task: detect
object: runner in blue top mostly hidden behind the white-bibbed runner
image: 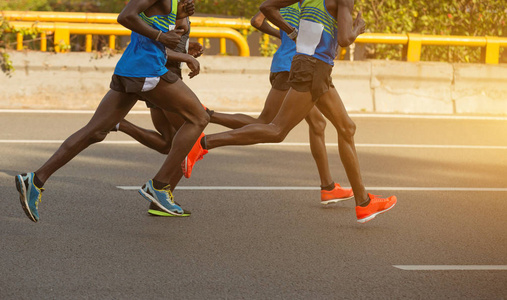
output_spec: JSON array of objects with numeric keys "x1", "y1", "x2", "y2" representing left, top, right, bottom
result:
[{"x1": 206, "y1": 3, "x2": 354, "y2": 204}]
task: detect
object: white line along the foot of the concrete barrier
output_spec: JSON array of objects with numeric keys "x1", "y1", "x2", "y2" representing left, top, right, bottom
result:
[{"x1": 0, "y1": 109, "x2": 507, "y2": 121}]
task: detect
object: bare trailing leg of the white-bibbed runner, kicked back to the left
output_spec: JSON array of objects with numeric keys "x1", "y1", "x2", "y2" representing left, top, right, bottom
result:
[{"x1": 206, "y1": 89, "x2": 314, "y2": 149}]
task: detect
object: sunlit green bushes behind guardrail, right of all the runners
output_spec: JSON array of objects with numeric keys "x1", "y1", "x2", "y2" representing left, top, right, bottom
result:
[{"x1": 356, "y1": 0, "x2": 507, "y2": 62}]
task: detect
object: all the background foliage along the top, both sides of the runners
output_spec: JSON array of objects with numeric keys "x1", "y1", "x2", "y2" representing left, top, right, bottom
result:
[{"x1": 0, "y1": 0, "x2": 507, "y2": 62}]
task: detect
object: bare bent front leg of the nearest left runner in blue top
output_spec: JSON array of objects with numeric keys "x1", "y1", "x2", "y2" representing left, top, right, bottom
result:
[{"x1": 144, "y1": 80, "x2": 209, "y2": 188}]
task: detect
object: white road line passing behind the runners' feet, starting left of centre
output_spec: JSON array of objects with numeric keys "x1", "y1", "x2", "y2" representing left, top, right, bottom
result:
[{"x1": 116, "y1": 185, "x2": 507, "y2": 192}]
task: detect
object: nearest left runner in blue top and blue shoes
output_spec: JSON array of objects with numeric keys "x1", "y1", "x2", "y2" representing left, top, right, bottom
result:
[{"x1": 15, "y1": 0, "x2": 209, "y2": 222}]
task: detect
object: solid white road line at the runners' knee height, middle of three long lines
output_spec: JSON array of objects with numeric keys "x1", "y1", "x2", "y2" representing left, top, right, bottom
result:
[{"x1": 0, "y1": 140, "x2": 507, "y2": 150}]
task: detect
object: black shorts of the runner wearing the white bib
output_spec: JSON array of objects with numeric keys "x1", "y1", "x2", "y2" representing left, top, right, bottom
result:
[{"x1": 289, "y1": 54, "x2": 334, "y2": 101}]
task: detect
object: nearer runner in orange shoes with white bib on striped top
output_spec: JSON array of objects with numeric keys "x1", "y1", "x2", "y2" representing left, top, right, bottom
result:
[{"x1": 189, "y1": 0, "x2": 397, "y2": 223}]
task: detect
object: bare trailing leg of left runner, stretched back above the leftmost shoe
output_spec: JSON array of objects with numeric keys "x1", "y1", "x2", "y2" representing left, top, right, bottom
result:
[{"x1": 35, "y1": 90, "x2": 137, "y2": 183}]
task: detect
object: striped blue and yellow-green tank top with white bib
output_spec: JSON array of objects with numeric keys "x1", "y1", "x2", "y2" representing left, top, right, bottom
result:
[{"x1": 296, "y1": 0, "x2": 338, "y2": 66}]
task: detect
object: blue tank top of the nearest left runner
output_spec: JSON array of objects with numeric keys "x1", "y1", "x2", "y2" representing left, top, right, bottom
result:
[{"x1": 114, "y1": 0, "x2": 178, "y2": 77}]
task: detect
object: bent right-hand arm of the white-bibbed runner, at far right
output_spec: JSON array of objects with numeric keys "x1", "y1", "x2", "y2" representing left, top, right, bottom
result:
[{"x1": 336, "y1": 0, "x2": 366, "y2": 47}]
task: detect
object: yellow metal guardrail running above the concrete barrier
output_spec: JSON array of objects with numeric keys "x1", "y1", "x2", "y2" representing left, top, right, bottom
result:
[{"x1": 0, "y1": 11, "x2": 507, "y2": 64}]
